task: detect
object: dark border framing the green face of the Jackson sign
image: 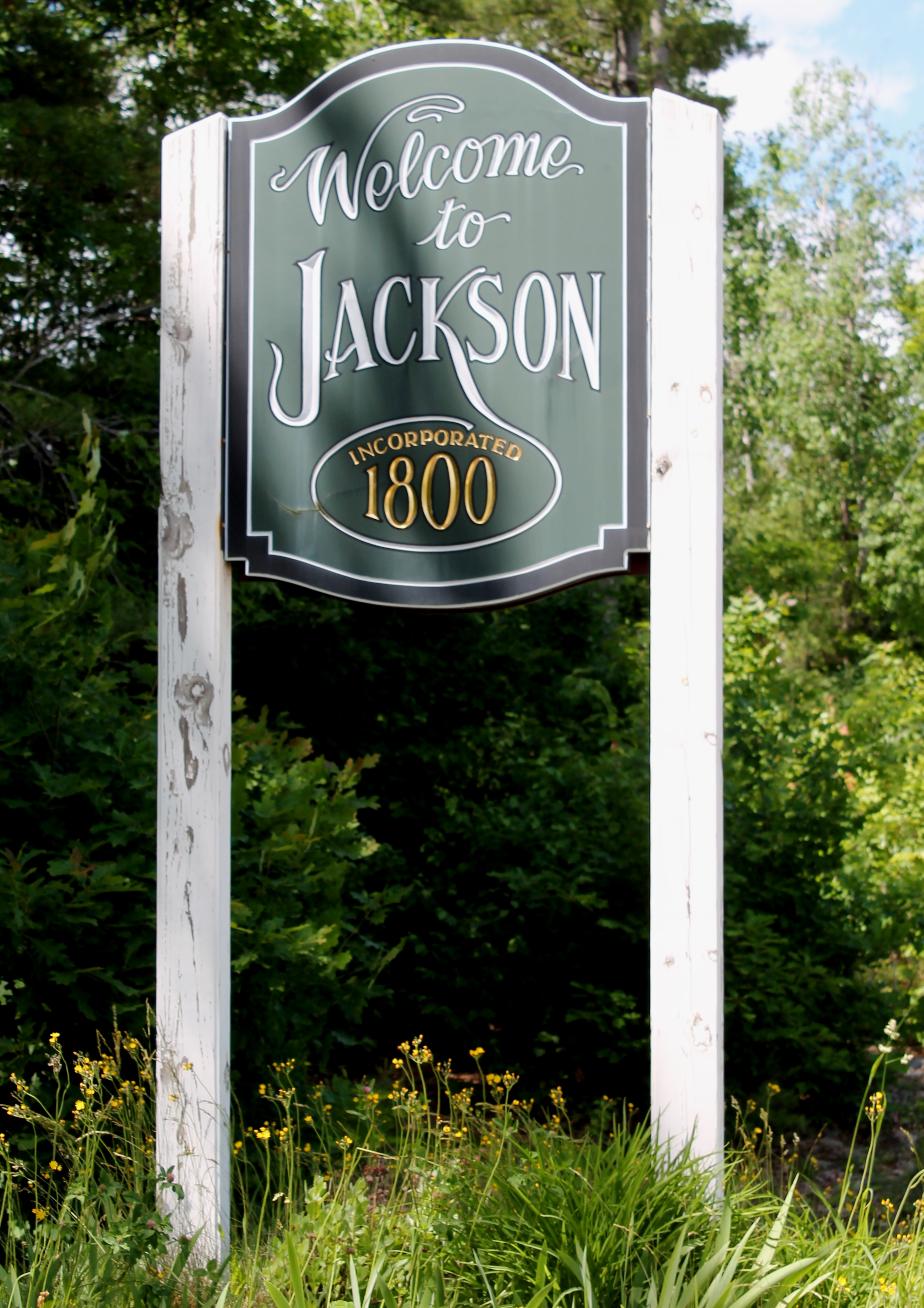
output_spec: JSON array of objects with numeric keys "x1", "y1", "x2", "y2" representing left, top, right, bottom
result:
[{"x1": 224, "y1": 41, "x2": 649, "y2": 608}]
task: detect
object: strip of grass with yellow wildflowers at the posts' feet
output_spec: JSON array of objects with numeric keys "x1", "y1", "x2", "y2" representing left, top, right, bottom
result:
[{"x1": 0, "y1": 1032, "x2": 924, "y2": 1308}]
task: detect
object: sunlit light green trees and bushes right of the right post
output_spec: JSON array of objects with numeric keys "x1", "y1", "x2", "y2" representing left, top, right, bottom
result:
[{"x1": 726, "y1": 68, "x2": 924, "y2": 1095}]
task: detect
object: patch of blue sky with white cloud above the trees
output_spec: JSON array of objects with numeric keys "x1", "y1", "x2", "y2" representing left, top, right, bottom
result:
[{"x1": 709, "y1": 0, "x2": 924, "y2": 143}]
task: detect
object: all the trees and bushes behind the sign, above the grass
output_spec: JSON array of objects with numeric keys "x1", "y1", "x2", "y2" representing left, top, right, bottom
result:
[{"x1": 0, "y1": 0, "x2": 924, "y2": 1124}]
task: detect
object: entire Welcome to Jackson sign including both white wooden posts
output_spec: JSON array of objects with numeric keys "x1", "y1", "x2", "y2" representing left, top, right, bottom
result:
[{"x1": 157, "y1": 51, "x2": 722, "y2": 1261}]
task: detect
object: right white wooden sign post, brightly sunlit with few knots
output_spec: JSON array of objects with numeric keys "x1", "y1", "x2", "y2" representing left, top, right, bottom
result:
[{"x1": 650, "y1": 92, "x2": 724, "y2": 1184}]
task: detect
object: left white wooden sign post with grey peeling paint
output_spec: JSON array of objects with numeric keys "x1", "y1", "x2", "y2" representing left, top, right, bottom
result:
[{"x1": 157, "y1": 114, "x2": 230, "y2": 1264}]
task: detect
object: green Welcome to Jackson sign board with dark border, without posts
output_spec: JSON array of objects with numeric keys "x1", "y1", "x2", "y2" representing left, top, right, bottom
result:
[{"x1": 225, "y1": 41, "x2": 648, "y2": 608}]
